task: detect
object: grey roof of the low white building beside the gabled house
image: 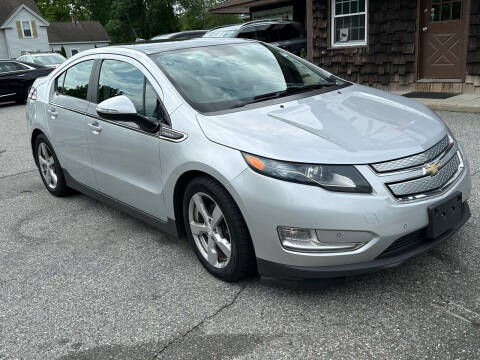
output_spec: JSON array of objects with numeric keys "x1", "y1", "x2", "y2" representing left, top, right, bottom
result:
[{"x1": 47, "y1": 21, "x2": 110, "y2": 43}]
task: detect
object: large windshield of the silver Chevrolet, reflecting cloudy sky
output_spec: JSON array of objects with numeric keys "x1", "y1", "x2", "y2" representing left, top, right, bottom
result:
[{"x1": 152, "y1": 42, "x2": 346, "y2": 112}]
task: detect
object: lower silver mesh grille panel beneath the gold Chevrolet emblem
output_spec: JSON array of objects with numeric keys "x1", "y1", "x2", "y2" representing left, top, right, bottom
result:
[{"x1": 387, "y1": 153, "x2": 461, "y2": 198}]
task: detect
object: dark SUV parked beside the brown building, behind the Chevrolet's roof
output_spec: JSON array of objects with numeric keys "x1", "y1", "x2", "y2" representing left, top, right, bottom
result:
[{"x1": 203, "y1": 20, "x2": 307, "y2": 55}]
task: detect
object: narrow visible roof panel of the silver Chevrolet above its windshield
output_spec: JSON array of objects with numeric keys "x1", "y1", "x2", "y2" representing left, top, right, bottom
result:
[{"x1": 112, "y1": 38, "x2": 252, "y2": 55}]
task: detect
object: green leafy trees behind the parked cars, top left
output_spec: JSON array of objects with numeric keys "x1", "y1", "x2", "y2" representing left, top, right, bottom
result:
[{"x1": 37, "y1": 0, "x2": 244, "y2": 44}]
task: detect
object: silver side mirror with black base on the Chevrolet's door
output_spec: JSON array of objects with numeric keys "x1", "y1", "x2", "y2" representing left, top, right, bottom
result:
[{"x1": 96, "y1": 95, "x2": 160, "y2": 133}]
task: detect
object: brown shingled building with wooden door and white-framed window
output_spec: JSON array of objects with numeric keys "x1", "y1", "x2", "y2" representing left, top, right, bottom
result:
[{"x1": 211, "y1": 0, "x2": 480, "y2": 94}]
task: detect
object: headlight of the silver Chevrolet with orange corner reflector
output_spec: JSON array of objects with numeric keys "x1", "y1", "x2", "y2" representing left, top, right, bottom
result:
[{"x1": 242, "y1": 153, "x2": 372, "y2": 193}]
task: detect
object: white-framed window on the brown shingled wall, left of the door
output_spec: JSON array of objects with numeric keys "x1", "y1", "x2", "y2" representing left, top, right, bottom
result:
[{"x1": 332, "y1": 0, "x2": 368, "y2": 47}]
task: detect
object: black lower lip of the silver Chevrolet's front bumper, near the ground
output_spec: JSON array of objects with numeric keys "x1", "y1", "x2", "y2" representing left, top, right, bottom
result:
[{"x1": 257, "y1": 202, "x2": 471, "y2": 280}]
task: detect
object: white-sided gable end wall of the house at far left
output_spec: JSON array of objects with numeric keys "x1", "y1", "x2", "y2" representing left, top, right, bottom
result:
[{"x1": 4, "y1": 8, "x2": 49, "y2": 58}]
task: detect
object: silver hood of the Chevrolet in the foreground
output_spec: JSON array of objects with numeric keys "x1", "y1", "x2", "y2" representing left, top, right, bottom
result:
[{"x1": 197, "y1": 85, "x2": 446, "y2": 164}]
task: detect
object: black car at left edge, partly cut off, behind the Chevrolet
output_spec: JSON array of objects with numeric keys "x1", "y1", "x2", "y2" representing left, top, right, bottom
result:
[{"x1": 0, "y1": 60, "x2": 53, "y2": 103}]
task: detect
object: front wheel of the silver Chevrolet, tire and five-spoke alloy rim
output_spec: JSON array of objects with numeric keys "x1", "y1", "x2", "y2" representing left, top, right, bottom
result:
[{"x1": 183, "y1": 177, "x2": 255, "y2": 282}]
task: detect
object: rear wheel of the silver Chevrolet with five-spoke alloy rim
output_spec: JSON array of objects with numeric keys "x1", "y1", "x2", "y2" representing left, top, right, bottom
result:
[{"x1": 35, "y1": 135, "x2": 71, "y2": 197}]
